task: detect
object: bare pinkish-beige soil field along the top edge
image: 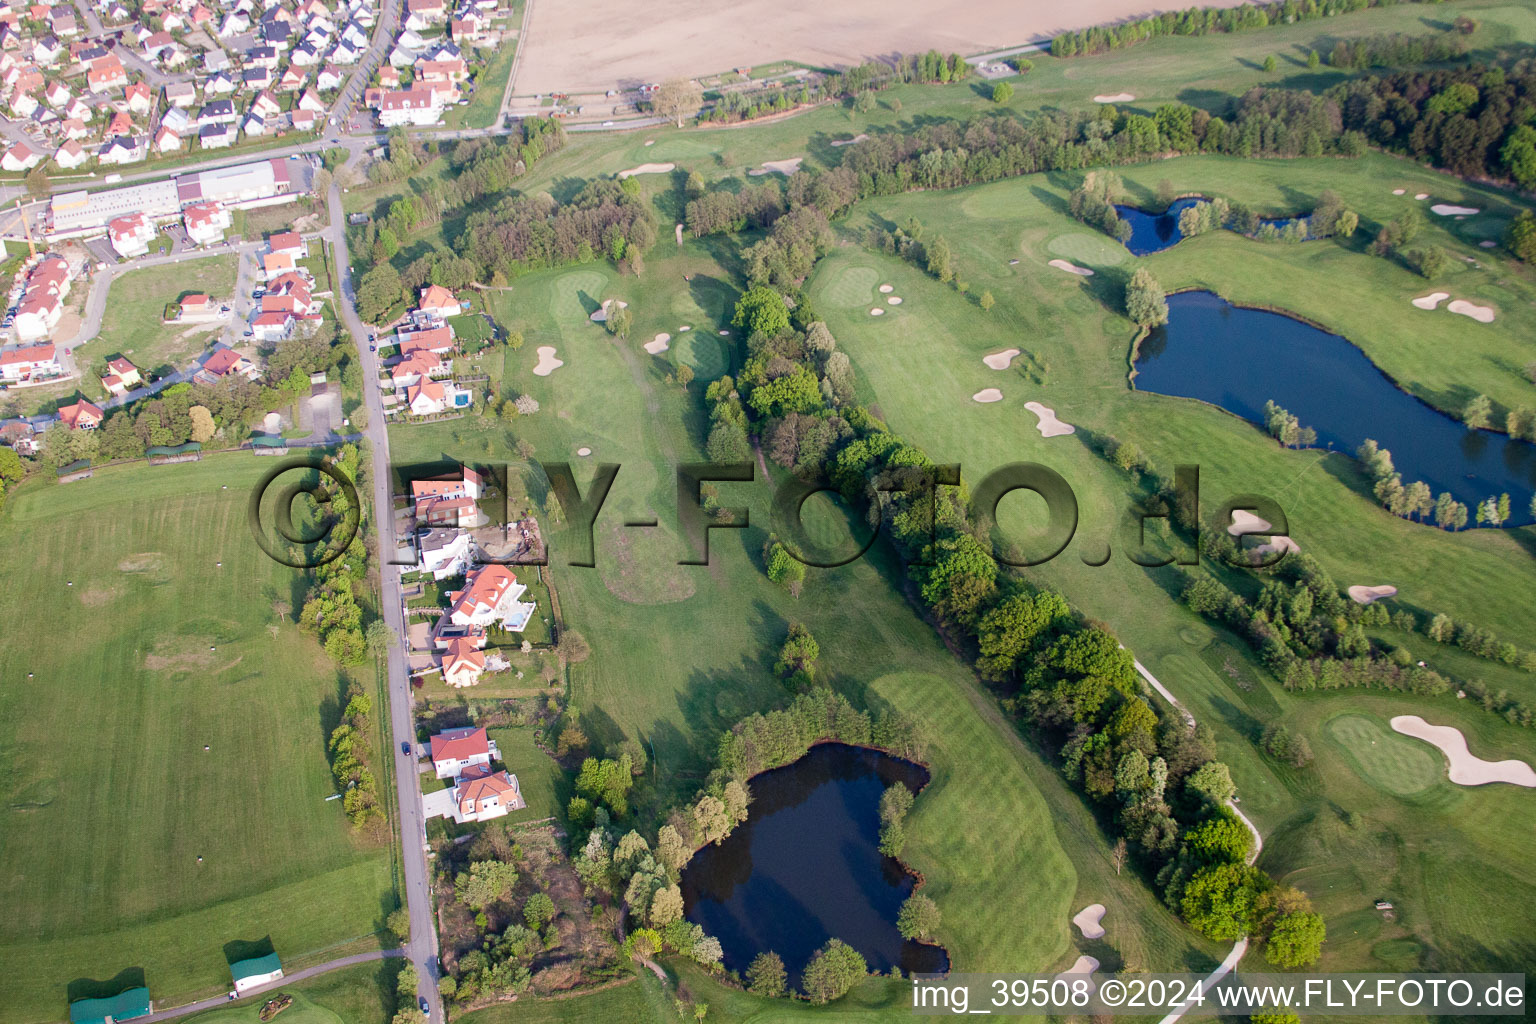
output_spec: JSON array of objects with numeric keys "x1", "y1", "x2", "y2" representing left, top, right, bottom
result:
[{"x1": 513, "y1": 0, "x2": 1235, "y2": 95}]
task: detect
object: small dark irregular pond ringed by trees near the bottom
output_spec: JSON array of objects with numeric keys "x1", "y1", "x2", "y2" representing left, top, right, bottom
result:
[{"x1": 682, "y1": 743, "x2": 949, "y2": 984}]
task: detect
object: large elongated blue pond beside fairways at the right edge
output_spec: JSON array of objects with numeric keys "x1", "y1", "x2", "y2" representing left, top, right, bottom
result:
[{"x1": 1135, "y1": 292, "x2": 1536, "y2": 524}]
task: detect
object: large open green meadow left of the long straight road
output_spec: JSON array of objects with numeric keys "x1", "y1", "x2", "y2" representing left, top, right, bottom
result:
[{"x1": 0, "y1": 456, "x2": 395, "y2": 1021}]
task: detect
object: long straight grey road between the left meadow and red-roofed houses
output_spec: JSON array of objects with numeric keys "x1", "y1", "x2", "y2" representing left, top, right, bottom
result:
[{"x1": 324, "y1": 184, "x2": 444, "y2": 1024}]
